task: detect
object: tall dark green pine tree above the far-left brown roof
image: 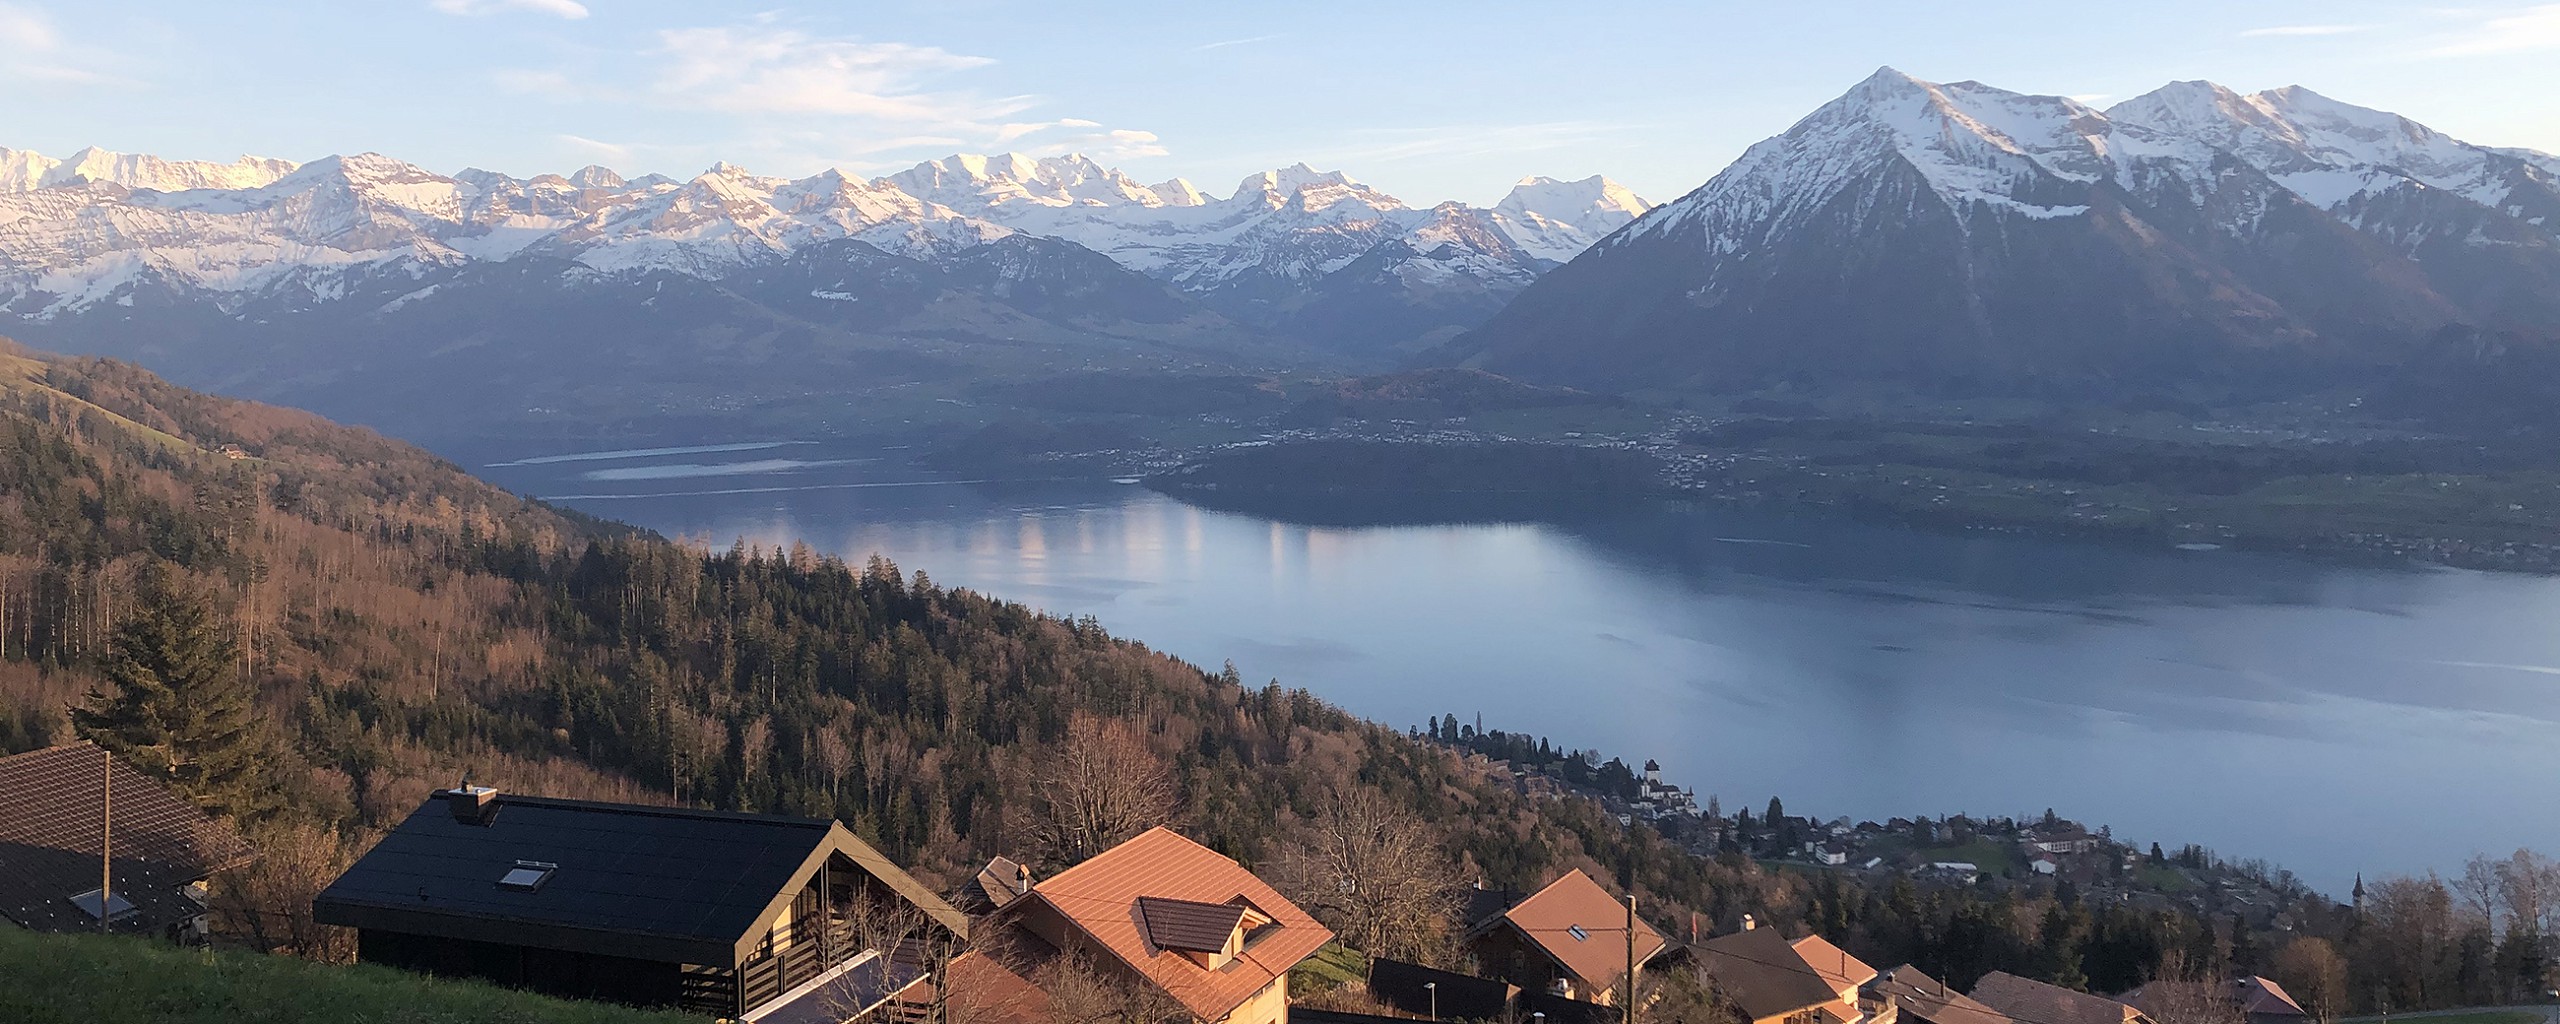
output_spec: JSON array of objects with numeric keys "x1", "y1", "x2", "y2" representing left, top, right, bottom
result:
[{"x1": 72, "y1": 573, "x2": 276, "y2": 817}]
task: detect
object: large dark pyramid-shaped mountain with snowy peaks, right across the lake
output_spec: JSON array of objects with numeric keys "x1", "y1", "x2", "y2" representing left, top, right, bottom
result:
[{"x1": 1449, "y1": 69, "x2": 2560, "y2": 392}]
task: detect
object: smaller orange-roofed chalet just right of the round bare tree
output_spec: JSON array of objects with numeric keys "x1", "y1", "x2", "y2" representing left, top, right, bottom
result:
[{"x1": 1459, "y1": 868, "x2": 1669, "y2": 1004}]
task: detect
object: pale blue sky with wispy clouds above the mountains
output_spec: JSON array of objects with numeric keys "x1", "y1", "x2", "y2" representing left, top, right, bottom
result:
[{"x1": 0, "y1": 0, "x2": 2560, "y2": 202}]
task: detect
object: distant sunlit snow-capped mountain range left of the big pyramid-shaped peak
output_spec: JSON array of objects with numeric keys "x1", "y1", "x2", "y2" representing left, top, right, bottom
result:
[{"x1": 0, "y1": 148, "x2": 1646, "y2": 353}]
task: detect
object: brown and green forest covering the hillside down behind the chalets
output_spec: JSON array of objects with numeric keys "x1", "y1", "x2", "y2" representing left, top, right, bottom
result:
[{"x1": 0, "y1": 353, "x2": 2560, "y2": 1014}]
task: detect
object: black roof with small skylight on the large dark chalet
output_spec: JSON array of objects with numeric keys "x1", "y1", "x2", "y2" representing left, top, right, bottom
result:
[{"x1": 315, "y1": 794, "x2": 835, "y2": 965}]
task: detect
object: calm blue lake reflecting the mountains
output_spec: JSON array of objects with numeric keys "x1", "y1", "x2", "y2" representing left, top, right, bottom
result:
[{"x1": 471, "y1": 445, "x2": 2560, "y2": 893}]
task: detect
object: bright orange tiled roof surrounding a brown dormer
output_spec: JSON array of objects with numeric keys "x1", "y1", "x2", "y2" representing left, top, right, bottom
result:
[{"x1": 1032, "y1": 827, "x2": 1334, "y2": 1021}]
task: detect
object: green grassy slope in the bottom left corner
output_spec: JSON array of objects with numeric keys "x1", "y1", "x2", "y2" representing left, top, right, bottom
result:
[{"x1": 0, "y1": 927, "x2": 701, "y2": 1024}]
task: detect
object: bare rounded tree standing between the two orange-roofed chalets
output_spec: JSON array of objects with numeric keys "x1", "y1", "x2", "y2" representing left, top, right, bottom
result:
[{"x1": 1272, "y1": 788, "x2": 1459, "y2": 963}]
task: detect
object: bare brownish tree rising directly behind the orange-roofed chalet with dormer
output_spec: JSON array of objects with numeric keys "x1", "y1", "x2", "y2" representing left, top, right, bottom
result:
[{"x1": 1032, "y1": 714, "x2": 1175, "y2": 865}]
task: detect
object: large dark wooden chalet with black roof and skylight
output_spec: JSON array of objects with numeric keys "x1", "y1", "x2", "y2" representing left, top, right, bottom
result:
[{"x1": 312, "y1": 786, "x2": 968, "y2": 1024}]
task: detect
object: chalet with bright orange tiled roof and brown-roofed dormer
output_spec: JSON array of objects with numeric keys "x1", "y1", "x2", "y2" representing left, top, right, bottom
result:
[{"x1": 975, "y1": 827, "x2": 1334, "y2": 1024}]
